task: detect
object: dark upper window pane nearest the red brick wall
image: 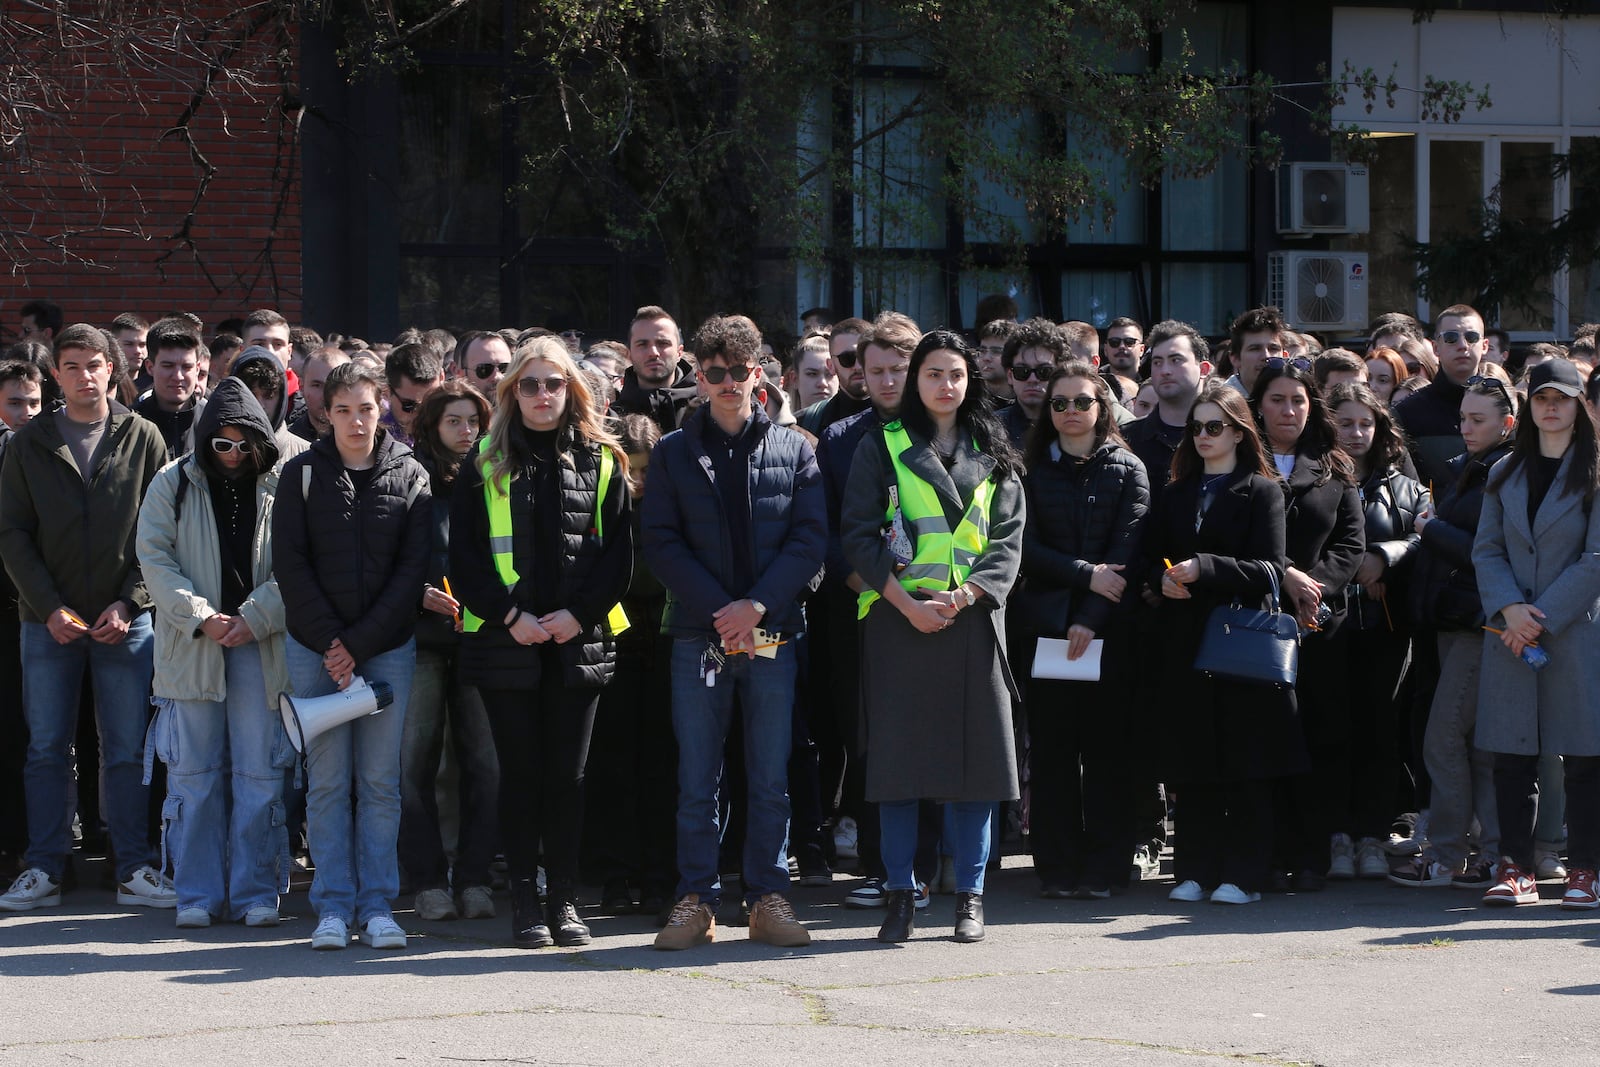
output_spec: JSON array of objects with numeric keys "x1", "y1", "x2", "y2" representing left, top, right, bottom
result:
[{"x1": 397, "y1": 66, "x2": 506, "y2": 245}]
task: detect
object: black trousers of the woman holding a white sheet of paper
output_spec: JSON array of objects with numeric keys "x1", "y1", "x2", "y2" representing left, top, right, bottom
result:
[{"x1": 1027, "y1": 678, "x2": 1134, "y2": 889}]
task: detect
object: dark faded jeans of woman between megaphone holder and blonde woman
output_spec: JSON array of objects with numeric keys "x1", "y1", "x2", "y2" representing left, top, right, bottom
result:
[{"x1": 400, "y1": 648, "x2": 499, "y2": 893}]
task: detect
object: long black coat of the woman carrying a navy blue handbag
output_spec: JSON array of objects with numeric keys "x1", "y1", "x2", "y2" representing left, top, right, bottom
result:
[{"x1": 1144, "y1": 470, "x2": 1309, "y2": 784}]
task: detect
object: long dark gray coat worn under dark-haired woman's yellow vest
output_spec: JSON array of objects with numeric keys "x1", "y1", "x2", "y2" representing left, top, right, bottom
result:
[{"x1": 840, "y1": 427, "x2": 1026, "y2": 803}]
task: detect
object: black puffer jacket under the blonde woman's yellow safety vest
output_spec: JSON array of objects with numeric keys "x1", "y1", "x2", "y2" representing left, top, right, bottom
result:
[{"x1": 450, "y1": 429, "x2": 634, "y2": 689}]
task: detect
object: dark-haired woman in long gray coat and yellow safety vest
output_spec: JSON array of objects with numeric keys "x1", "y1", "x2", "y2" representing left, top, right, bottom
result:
[{"x1": 840, "y1": 330, "x2": 1024, "y2": 941}]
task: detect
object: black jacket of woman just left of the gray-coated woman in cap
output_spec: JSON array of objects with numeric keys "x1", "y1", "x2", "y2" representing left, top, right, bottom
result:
[{"x1": 1411, "y1": 445, "x2": 1510, "y2": 630}]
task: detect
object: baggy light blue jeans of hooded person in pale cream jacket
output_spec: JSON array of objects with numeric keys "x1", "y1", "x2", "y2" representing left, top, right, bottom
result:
[{"x1": 150, "y1": 638, "x2": 294, "y2": 920}]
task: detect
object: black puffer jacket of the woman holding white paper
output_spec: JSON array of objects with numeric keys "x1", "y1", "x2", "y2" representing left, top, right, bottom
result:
[{"x1": 1006, "y1": 443, "x2": 1150, "y2": 637}]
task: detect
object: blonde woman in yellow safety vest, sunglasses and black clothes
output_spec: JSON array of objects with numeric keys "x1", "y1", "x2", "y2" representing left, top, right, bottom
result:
[{"x1": 450, "y1": 338, "x2": 634, "y2": 949}]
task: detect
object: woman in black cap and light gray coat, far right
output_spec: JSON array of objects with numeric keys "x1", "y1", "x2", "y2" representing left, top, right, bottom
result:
[{"x1": 1472, "y1": 360, "x2": 1600, "y2": 910}]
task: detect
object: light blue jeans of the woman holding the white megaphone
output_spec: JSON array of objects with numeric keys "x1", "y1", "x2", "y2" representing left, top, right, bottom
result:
[{"x1": 286, "y1": 637, "x2": 416, "y2": 926}]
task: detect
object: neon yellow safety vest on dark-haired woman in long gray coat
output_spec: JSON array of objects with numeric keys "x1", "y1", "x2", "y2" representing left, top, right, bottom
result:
[{"x1": 856, "y1": 422, "x2": 995, "y2": 619}]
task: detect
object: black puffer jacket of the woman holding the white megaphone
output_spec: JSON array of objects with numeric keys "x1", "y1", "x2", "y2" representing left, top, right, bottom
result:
[{"x1": 272, "y1": 434, "x2": 434, "y2": 664}]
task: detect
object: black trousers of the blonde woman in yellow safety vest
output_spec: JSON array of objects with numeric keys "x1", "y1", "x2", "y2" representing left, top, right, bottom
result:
[{"x1": 478, "y1": 643, "x2": 600, "y2": 901}]
